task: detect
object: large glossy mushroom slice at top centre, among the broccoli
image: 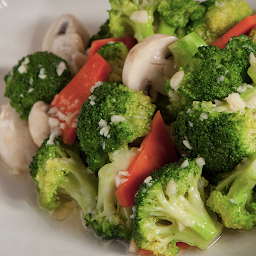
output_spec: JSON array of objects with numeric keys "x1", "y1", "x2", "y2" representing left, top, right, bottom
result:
[{"x1": 122, "y1": 34, "x2": 178, "y2": 101}]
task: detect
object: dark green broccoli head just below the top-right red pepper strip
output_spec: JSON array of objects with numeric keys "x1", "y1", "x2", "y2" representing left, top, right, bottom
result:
[{"x1": 178, "y1": 46, "x2": 243, "y2": 101}]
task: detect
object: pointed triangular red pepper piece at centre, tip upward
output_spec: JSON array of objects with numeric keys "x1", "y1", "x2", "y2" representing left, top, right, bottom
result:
[{"x1": 116, "y1": 111, "x2": 178, "y2": 207}]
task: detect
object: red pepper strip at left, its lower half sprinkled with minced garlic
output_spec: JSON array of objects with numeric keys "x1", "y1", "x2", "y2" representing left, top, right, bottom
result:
[{"x1": 51, "y1": 53, "x2": 111, "y2": 145}]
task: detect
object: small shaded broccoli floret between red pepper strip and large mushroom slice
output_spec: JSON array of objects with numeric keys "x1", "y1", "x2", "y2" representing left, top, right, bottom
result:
[{"x1": 98, "y1": 42, "x2": 129, "y2": 83}]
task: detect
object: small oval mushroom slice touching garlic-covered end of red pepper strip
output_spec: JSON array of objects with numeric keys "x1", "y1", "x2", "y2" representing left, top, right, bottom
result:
[{"x1": 28, "y1": 101, "x2": 51, "y2": 147}]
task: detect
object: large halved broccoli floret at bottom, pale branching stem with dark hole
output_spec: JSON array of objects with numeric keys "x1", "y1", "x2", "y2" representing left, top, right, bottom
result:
[{"x1": 133, "y1": 158, "x2": 223, "y2": 256}]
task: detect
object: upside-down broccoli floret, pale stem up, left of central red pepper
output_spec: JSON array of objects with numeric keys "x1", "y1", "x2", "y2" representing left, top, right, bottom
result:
[{"x1": 85, "y1": 146, "x2": 137, "y2": 242}]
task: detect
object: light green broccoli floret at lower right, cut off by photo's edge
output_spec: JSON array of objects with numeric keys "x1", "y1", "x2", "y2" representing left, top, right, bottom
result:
[{"x1": 206, "y1": 153, "x2": 256, "y2": 229}]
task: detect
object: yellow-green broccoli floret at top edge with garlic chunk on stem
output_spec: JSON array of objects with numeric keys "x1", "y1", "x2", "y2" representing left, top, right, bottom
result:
[{"x1": 109, "y1": 0, "x2": 161, "y2": 42}]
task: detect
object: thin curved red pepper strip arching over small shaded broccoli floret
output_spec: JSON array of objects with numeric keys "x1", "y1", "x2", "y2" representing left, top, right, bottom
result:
[{"x1": 87, "y1": 37, "x2": 137, "y2": 61}]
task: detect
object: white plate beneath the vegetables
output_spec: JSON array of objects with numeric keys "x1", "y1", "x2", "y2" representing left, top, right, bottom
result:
[{"x1": 0, "y1": 0, "x2": 256, "y2": 256}]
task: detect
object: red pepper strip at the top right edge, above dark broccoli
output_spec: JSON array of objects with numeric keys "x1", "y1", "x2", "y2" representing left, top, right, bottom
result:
[{"x1": 213, "y1": 15, "x2": 256, "y2": 48}]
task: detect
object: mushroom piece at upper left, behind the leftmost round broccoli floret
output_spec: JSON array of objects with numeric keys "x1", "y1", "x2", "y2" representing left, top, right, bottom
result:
[{"x1": 42, "y1": 14, "x2": 90, "y2": 75}]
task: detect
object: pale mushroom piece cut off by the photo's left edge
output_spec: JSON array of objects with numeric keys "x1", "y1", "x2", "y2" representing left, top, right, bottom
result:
[{"x1": 0, "y1": 103, "x2": 38, "y2": 174}]
